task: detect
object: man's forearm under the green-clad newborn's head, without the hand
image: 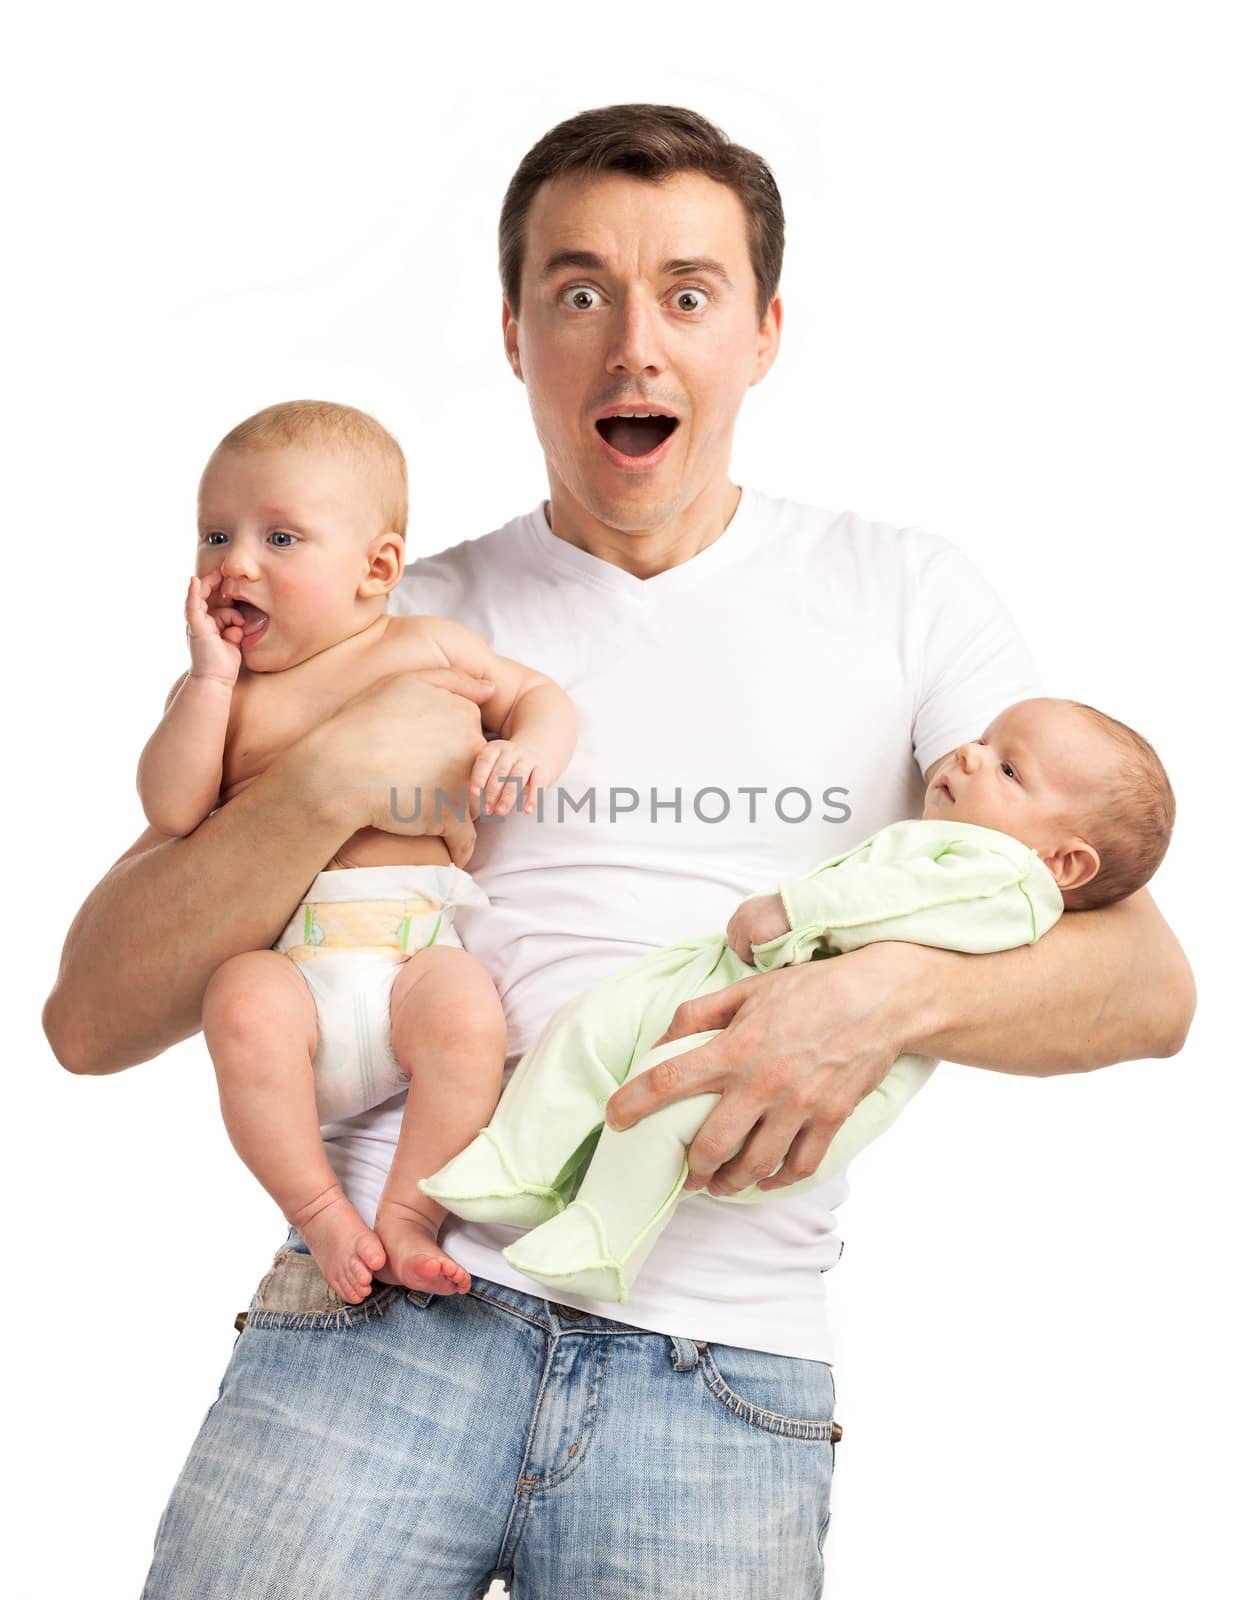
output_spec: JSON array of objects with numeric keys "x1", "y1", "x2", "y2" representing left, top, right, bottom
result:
[{"x1": 897, "y1": 890, "x2": 1195, "y2": 1077}]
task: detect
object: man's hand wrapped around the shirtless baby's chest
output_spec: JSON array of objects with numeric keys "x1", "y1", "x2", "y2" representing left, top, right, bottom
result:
[{"x1": 278, "y1": 667, "x2": 493, "y2": 867}]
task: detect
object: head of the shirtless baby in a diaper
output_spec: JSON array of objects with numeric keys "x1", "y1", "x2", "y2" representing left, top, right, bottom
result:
[{"x1": 197, "y1": 400, "x2": 406, "y2": 672}]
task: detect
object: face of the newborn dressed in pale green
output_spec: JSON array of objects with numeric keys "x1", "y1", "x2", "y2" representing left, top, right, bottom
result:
[{"x1": 923, "y1": 699, "x2": 1116, "y2": 858}]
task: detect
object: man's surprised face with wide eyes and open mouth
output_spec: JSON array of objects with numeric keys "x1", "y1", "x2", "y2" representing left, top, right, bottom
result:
[{"x1": 505, "y1": 173, "x2": 780, "y2": 533}]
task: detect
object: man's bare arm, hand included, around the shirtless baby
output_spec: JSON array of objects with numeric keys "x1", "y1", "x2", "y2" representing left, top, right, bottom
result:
[{"x1": 43, "y1": 670, "x2": 491, "y2": 1074}]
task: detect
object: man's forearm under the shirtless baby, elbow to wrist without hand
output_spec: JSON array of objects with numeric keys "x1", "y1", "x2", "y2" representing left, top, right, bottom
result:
[{"x1": 43, "y1": 766, "x2": 353, "y2": 1074}]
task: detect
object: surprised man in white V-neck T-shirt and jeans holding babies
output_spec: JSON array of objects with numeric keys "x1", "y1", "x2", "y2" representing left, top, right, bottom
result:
[{"x1": 45, "y1": 106, "x2": 1193, "y2": 1600}]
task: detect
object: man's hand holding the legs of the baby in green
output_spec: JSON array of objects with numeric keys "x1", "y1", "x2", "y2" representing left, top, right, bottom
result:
[{"x1": 608, "y1": 944, "x2": 913, "y2": 1195}]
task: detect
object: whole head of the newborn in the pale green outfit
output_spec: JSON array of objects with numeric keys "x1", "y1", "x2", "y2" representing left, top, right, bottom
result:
[{"x1": 923, "y1": 699, "x2": 1174, "y2": 910}]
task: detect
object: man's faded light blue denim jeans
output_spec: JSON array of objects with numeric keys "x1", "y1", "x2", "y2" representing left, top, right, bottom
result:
[{"x1": 144, "y1": 1234, "x2": 840, "y2": 1600}]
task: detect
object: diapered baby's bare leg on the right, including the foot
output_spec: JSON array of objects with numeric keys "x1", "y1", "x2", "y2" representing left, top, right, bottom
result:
[{"x1": 376, "y1": 946, "x2": 505, "y2": 1294}]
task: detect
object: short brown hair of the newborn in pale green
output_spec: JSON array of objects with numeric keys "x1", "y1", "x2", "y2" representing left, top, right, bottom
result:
[{"x1": 1065, "y1": 701, "x2": 1177, "y2": 910}]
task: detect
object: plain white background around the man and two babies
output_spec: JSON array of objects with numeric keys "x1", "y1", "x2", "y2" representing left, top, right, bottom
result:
[{"x1": 0, "y1": 0, "x2": 1233, "y2": 1600}]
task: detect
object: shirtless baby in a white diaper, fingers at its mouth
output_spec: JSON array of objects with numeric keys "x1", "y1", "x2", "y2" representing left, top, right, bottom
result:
[{"x1": 138, "y1": 402, "x2": 577, "y2": 1304}]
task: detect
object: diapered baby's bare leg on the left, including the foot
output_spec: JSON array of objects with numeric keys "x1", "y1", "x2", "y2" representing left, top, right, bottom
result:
[{"x1": 202, "y1": 950, "x2": 385, "y2": 1306}]
